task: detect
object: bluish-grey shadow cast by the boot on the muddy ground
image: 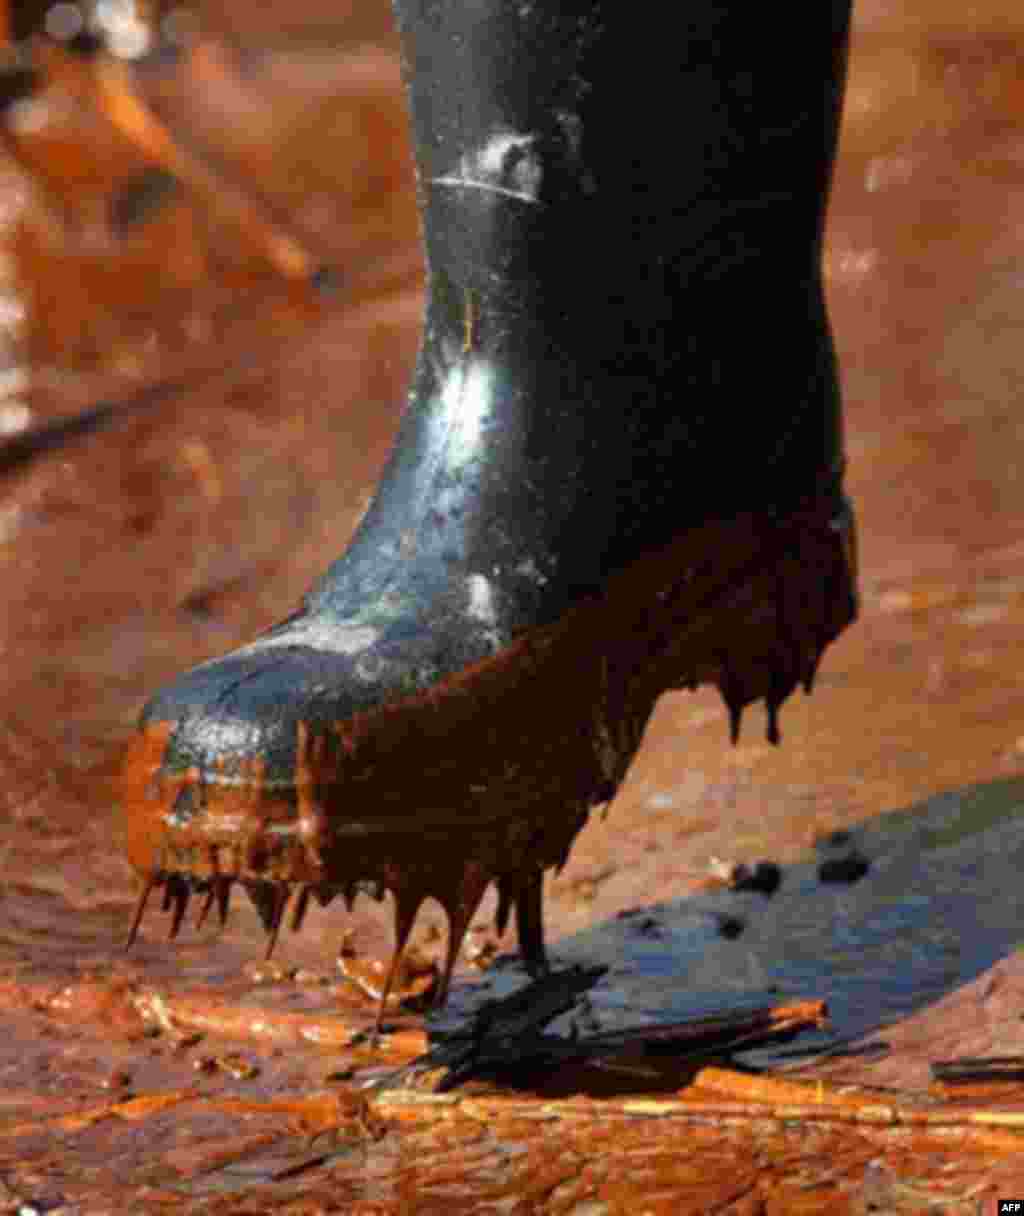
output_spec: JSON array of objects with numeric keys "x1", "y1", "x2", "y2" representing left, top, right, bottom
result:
[{"x1": 542, "y1": 781, "x2": 1024, "y2": 1062}]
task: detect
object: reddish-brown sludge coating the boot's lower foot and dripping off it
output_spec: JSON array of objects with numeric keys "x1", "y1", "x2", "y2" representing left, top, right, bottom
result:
[{"x1": 123, "y1": 502, "x2": 854, "y2": 1026}]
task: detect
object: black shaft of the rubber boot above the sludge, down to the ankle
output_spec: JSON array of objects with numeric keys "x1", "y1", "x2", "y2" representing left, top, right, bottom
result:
[{"x1": 317, "y1": 0, "x2": 849, "y2": 632}]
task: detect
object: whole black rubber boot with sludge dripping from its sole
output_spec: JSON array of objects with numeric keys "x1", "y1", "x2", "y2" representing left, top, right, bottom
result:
[{"x1": 119, "y1": 0, "x2": 855, "y2": 1021}]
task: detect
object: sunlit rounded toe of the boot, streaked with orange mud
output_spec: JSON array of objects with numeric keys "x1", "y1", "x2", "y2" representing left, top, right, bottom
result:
[{"x1": 122, "y1": 636, "x2": 372, "y2": 923}]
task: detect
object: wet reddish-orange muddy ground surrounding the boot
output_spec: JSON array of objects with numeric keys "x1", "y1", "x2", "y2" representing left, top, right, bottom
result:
[{"x1": 0, "y1": 0, "x2": 1024, "y2": 1214}]
